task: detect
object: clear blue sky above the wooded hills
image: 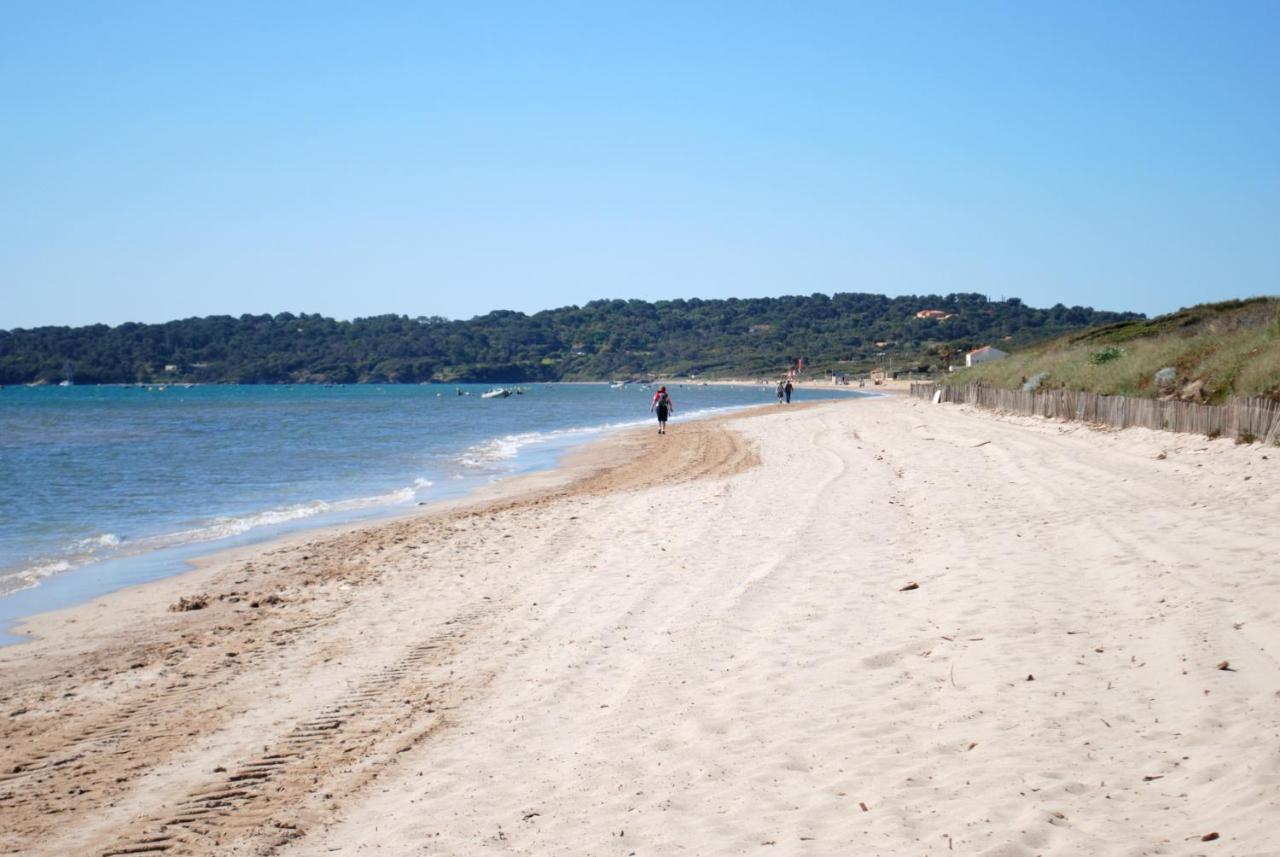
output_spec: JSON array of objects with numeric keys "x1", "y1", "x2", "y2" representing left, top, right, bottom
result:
[{"x1": 0, "y1": 0, "x2": 1280, "y2": 327}]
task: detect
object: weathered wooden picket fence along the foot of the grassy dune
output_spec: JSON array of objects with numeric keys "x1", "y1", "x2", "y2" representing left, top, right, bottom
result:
[{"x1": 911, "y1": 382, "x2": 1280, "y2": 446}]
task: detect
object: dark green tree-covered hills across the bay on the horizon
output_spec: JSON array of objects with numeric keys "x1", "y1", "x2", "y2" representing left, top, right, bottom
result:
[{"x1": 0, "y1": 293, "x2": 1139, "y2": 384}]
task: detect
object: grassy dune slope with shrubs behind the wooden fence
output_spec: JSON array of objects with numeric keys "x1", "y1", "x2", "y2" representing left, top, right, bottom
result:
[{"x1": 947, "y1": 298, "x2": 1280, "y2": 403}]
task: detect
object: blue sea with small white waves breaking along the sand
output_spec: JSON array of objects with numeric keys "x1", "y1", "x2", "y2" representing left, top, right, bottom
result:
[{"x1": 0, "y1": 384, "x2": 856, "y2": 642}]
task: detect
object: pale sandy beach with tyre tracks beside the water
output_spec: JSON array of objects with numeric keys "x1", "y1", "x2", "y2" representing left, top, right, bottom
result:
[{"x1": 0, "y1": 397, "x2": 1280, "y2": 857}]
